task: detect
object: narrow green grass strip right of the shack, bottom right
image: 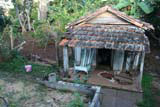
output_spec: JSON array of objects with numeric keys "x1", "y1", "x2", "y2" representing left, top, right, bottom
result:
[{"x1": 138, "y1": 74, "x2": 156, "y2": 107}]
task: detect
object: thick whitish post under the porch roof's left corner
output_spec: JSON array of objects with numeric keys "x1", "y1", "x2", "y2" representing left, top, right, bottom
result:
[{"x1": 63, "y1": 47, "x2": 69, "y2": 72}]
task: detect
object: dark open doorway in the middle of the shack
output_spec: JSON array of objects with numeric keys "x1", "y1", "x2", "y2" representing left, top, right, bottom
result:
[{"x1": 97, "y1": 49, "x2": 112, "y2": 67}]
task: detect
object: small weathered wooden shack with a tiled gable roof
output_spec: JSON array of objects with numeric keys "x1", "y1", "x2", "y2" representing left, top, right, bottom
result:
[{"x1": 60, "y1": 6, "x2": 154, "y2": 86}]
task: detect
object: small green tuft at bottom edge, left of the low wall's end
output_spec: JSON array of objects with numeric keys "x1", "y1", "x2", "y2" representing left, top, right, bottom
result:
[{"x1": 67, "y1": 93, "x2": 84, "y2": 107}]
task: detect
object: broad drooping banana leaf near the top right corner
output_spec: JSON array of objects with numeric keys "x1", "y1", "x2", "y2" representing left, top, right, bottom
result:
[{"x1": 138, "y1": 2, "x2": 154, "y2": 14}]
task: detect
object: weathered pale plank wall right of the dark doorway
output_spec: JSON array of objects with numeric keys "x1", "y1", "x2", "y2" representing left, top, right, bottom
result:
[{"x1": 112, "y1": 50, "x2": 143, "y2": 72}]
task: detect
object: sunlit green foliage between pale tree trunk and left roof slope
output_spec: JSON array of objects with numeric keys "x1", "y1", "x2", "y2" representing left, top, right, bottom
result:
[{"x1": 48, "y1": 0, "x2": 115, "y2": 35}]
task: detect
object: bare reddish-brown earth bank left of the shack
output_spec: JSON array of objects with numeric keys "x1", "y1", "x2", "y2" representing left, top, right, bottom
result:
[{"x1": 21, "y1": 37, "x2": 56, "y2": 61}]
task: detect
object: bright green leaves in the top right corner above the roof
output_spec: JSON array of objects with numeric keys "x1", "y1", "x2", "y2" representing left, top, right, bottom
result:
[{"x1": 114, "y1": 0, "x2": 160, "y2": 18}]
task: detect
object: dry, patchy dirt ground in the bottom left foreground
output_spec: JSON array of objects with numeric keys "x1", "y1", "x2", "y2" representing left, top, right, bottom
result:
[{"x1": 0, "y1": 72, "x2": 74, "y2": 107}]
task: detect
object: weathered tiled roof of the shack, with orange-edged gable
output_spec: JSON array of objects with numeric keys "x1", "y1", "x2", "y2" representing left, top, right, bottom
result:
[{"x1": 60, "y1": 6, "x2": 153, "y2": 53}]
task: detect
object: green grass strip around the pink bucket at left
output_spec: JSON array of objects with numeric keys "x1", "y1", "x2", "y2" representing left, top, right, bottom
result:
[{"x1": 0, "y1": 55, "x2": 57, "y2": 76}]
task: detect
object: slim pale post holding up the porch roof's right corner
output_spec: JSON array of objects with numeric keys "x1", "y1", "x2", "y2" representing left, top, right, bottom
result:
[{"x1": 139, "y1": 52, "x2": 145, "y2": 86}]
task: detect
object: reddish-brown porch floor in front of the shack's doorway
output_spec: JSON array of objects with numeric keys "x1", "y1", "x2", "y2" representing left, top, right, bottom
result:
[{"x1": 67, "y1": 70, "x2": 142, "y2": 92}]
